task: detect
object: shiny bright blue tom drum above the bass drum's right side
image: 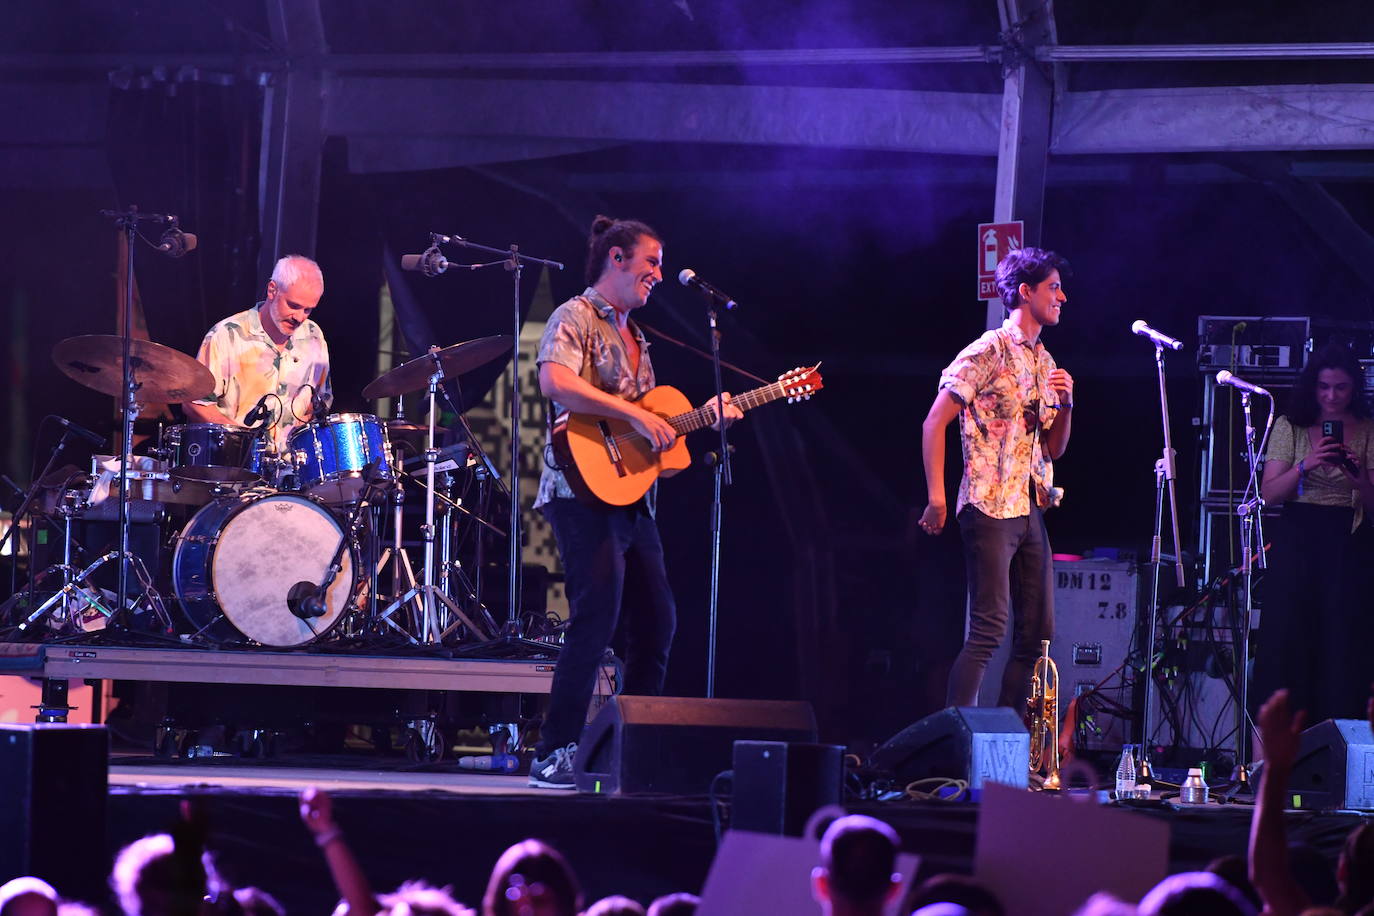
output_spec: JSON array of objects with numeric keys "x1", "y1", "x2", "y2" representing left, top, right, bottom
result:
[{"x1": 287, "y1": 413, "x2": 393, "y2": 505}]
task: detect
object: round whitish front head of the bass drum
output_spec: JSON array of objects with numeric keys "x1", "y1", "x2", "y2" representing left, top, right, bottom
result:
[{"x1": 210, "y1": 493, "x2": 354, "y2": 647}]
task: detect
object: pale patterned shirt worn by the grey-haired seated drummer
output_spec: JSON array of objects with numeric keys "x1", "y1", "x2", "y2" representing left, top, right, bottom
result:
[{"x1": 196, "y1": 302, "x2": 334, "y2": 452}]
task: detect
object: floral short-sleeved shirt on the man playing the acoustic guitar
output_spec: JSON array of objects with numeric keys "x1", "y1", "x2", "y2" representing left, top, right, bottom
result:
[{"x1": 534, "y1": 287, "x2": 657, "y2": 514}]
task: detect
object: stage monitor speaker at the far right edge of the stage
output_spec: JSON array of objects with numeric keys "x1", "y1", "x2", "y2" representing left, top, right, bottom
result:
[{"x1": 1289, "y1": 718, "x2": 1374, "y2": 810}]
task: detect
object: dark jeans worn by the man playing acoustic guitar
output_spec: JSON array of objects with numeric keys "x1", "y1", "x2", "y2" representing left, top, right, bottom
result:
[{"x1": 534, "y1": 500, "x2": 677, "y2": 757}]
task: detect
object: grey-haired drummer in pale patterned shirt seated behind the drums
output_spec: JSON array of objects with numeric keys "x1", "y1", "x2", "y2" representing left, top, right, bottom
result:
[{"x1": 184, "y1": 254, "x2": 334, "y2": 453}]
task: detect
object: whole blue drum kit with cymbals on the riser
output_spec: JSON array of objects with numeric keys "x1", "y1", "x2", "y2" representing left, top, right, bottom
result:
[{"x1": 19, "y1": 329, "x2": 511, "y2": 648}]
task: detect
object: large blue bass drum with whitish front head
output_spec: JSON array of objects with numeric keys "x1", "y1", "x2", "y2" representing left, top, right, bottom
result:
[{"x1": 172, "y1": 493, "x2": 356, "y2": 648}]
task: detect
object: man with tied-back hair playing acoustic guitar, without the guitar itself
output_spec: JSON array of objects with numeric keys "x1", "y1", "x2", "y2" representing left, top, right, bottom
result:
[{"x1": 529, "y1": 216, "x2": 743, "y2": 788}]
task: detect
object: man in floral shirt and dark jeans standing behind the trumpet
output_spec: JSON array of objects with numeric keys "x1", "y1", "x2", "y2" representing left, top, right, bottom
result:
[{"x1": 921, "y1": 249, "x2": 1073, "y2": 709}]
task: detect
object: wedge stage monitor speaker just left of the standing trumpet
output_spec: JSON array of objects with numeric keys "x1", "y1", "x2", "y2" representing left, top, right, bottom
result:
[{"x1": 871, "y1": 706, "x2": 1031, "y2": 795}]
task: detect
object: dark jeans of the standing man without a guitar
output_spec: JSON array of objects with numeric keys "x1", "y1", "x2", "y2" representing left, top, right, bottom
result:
[{"x1": 945, "y1": 505, "x2": 1054, "y2": 711}]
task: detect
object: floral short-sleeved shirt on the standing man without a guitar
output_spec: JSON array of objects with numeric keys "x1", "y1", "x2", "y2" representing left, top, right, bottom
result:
[{"x1": 940, "y1": 319, "x2": 1063, "y2": 519}]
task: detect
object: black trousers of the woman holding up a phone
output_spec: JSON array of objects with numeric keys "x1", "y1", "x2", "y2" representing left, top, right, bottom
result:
[{"x1": 1249, "y1": 503, "x2": 1374, "y2": 725}]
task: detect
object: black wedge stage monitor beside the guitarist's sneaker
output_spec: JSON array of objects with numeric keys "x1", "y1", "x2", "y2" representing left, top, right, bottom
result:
[{"x1": 573, "y1": 696, "x2": 816, "y2": 795}]
